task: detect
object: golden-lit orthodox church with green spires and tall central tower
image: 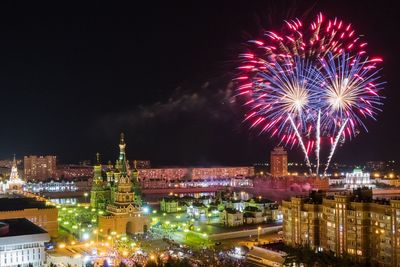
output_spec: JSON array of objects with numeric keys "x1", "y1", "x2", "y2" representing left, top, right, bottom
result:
[{"x1": 90, "y1": 134, "x2": 149, "y2": 234}]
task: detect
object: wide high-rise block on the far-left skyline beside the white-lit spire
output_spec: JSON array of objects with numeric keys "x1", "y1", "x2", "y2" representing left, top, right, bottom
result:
[{"x1": 24, "y1": 156, "x2": 57, "y2": 180}]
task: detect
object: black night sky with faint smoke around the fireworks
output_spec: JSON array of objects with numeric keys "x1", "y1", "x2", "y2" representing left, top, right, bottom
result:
[{"x1": 0, "y1": 0, "x2": 400, "y2": 165}]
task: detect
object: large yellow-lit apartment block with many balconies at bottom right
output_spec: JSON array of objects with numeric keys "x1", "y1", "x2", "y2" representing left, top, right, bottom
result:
[{"x1": 282, "y1": 188, "x2": 400, "y2": 266}]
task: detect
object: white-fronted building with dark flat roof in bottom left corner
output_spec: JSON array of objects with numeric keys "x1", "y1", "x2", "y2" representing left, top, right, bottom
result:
[{"x1": 0, "y1": 218, "x2": 50, "y2": 267}]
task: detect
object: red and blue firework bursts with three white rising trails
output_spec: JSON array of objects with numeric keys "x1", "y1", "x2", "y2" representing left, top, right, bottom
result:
[{"x1": 235, "y1": 13, "x2": 384, "y2": 175}]
